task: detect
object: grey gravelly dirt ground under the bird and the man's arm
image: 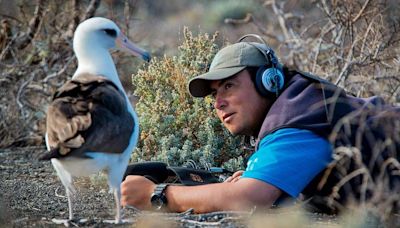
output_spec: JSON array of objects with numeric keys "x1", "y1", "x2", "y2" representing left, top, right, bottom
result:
[{"x1": 0, "y1": 147, "x2": 337, "y2": 227}]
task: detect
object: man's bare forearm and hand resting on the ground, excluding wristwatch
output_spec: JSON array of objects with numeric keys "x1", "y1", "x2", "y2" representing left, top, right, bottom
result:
[{"x1": 121, "y1": 176, "x2": 281, "y2": 213}]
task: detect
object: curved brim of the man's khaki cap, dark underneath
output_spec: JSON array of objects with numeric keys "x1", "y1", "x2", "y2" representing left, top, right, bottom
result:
[{"x1": 188, "y1": 66, "x2": 246, "y2": 97}]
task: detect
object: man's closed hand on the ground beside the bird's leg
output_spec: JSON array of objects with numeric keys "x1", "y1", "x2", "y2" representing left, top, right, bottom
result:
[{"x1": 121, "y1": 175, "x2": 156, "y2": 210}]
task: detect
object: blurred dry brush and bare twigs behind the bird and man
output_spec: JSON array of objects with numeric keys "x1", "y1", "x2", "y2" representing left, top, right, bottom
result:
[{"x1": 0, "y1": 0, "x2": 400, "y2": 153}]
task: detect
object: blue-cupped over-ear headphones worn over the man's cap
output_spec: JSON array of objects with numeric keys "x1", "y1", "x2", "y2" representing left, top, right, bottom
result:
[{"x1": 237, "y1": 34, "x2": 285, "y2": 97}]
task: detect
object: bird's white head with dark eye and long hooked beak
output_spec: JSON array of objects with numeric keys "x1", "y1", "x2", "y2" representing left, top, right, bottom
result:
[{"x1": 74, "y1": 17, "x2": 150, "y2": 62}]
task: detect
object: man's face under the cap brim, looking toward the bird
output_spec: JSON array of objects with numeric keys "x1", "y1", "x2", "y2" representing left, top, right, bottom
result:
[{"x1": 210, "y1": 70, "x2": 271, "y2": 136}]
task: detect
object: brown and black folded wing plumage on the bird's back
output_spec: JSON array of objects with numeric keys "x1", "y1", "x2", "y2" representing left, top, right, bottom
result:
[{"x1": 45, "y1": 74, "x2": 135, "y2": 159}]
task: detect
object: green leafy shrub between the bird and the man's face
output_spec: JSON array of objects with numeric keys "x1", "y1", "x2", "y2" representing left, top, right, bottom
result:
[{"x1": 132, "y1": 28, "x2": 243, "y2": 169}]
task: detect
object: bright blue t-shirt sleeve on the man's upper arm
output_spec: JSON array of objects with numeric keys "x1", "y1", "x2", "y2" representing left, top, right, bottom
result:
[{"x1": 242, "y1": 128, "x2": 332, "y2": 197}]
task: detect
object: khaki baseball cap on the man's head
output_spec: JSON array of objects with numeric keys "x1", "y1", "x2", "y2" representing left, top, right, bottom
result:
[{"x1": 188, "y1": 42, "x2": 270, "y2": 97}]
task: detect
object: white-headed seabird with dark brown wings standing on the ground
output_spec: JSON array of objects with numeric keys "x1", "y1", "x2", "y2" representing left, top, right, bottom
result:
[{"x1": 41, "y1": 17, "x2": 150, "y2": 224}]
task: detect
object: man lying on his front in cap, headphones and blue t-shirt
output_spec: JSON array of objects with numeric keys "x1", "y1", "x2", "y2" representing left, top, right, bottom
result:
[{"x1": 121, "y1": 36, "x2": 400, "y2": 213}]
